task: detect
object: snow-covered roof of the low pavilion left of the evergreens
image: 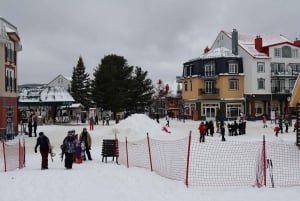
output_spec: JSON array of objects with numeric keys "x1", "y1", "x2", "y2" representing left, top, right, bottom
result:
[{"x1": 19, "y1": 86, "x2": 74, "y2": 103}]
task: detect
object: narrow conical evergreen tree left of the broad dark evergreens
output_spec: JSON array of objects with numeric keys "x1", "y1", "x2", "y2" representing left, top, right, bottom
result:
[{"x1": 71, "y1": 56, "x2": 91, "y2": 109}]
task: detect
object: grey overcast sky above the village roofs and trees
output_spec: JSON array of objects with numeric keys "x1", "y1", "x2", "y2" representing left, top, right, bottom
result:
[{"x1": 0, "y1": 0, "x2": 300, "y2": 84}]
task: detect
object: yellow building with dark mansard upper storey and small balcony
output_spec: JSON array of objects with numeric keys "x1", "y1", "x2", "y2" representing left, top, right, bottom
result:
[{"x1": 181, "y1": 47, "x2": 244, "y2": 120}]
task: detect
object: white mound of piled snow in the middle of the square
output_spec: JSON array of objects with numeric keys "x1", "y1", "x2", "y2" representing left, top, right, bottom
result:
[{"x1": 108, "y1": 114, "x2": 165, "y2": 141}]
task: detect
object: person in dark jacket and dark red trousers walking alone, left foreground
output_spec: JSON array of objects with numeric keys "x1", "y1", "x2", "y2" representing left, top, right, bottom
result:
[{"x1": 34, "y1": 132, "x2": 52, "y2": 170}]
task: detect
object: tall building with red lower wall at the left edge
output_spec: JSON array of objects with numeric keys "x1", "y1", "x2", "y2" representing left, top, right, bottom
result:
[{"x1": 0, "y1": 17, "x2": 22, "y2": 139}]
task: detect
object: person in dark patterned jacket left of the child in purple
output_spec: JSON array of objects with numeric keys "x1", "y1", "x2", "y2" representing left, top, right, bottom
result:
[{"x1": 61, "y1": 130, "x2": 76, "y2": 169}]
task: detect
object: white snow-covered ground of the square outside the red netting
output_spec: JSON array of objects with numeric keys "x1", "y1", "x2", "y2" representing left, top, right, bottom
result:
[{"x1": 0, "y1": 115, "x2": 300, "y2": 201}]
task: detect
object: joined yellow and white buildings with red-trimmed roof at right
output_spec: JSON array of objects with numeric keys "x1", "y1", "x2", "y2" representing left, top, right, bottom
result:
[{"x1": 181, "y1": 29, "x2": 300, "y2": 120}]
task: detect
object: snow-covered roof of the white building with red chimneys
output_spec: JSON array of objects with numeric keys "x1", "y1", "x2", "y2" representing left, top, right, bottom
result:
[{"x1": 223, "y1": 31, "x2": 294, "y2": 59}]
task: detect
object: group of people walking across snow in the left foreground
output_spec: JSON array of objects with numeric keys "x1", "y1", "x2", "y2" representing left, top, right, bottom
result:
[{"x1": 34, "y1": 128, "x2": 92, "y2": 170}]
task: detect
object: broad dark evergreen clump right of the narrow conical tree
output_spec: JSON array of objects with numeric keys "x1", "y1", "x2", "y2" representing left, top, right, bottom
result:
[{"x1": 93, "y1": 55, "x2": 153, "y2": 113}]
